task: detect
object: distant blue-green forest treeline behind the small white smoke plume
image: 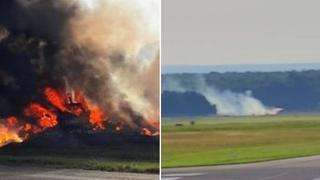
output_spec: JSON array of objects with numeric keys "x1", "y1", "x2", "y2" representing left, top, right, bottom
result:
[{"x1": 162, "y1": 70, "x2": 320, "y2": 115}]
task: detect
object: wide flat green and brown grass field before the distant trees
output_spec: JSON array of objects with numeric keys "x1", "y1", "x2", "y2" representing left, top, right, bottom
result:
[{"x1": 162, "y1": 116, "x2": 320, "y2": 168}]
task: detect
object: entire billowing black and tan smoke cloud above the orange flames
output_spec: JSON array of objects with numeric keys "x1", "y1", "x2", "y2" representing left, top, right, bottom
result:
[{"x1": 0, "y1": 0, "x2": 160, "y2": 145}]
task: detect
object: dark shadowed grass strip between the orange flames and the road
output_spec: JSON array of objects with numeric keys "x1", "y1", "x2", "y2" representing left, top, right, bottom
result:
[{"x1": 0, "y1": 144, "x2": 159, "y2": 173}]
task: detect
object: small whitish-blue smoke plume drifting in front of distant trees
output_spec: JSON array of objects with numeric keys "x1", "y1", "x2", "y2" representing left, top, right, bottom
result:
[{"x1": 162, "y1": 75, "x2": 282, "y2": 116}]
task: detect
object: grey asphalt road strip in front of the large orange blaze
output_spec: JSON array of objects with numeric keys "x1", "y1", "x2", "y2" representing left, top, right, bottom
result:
[{"x1": 0, "y1": 165, "x2": 159, "y2": 180}]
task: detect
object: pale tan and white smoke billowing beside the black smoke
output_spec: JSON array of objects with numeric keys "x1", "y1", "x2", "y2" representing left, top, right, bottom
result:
[{"x1": 64, "y1": 0, "x2": 160, "y2": 120}]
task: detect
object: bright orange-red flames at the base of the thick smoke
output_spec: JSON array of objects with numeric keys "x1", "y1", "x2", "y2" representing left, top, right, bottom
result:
[{"x1": 0, "y1": 86, "x2": 159, "y2": 147}]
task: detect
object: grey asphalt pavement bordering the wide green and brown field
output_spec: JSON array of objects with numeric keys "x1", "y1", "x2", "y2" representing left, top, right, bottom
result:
[{"x1": 161, "y1": 156, "x2": 320, "y2": 180}]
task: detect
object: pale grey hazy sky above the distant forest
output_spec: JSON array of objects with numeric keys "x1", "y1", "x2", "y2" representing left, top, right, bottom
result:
[{"x1": 162, "y1": 0, "x2": 320, "y2": 65}]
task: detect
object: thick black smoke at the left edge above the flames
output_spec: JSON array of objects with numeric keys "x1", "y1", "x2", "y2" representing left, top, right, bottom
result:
[{"x1": 0, "y1": 0, "x2": 75, "y2": 116}]
